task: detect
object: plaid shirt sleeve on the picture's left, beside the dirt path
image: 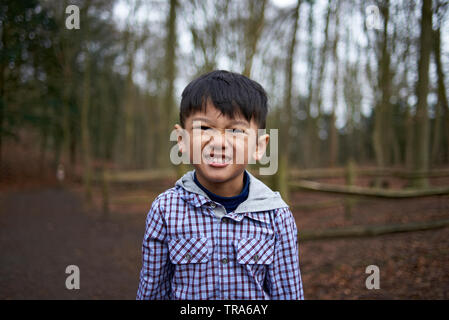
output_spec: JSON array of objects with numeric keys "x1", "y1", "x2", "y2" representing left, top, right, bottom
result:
[{"x1": 136, "y1": 199, "x2": 173, "y2": 300}]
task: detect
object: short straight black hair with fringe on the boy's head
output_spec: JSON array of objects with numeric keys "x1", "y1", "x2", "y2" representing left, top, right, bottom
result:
[{"x1": 179, "y1": 70, "x2": 268, "y2": 129}]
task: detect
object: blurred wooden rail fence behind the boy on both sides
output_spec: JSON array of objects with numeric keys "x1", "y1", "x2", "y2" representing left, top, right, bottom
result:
[{"x1": 92, "y1": 168, "x2": 449, "y2": 241}]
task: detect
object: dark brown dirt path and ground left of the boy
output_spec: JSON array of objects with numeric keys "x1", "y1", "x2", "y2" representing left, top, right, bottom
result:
[{"x1": 0, "y1": 189, "x2": 145, "y2": 299}]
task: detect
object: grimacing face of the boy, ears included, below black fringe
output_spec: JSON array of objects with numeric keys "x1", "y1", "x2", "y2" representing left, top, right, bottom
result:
[{"x1": 175, "y1": 103, "x2": 269, "y2": 183}]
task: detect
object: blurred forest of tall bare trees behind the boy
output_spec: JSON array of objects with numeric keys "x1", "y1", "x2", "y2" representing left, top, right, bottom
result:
[{"x1": 0, "y1": 0, "x2": 449, "y2": 186}]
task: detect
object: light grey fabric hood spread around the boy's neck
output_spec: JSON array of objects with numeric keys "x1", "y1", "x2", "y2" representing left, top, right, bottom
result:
[{"x1": 175, "y1": 170, "x2": 288, "y2": 213}]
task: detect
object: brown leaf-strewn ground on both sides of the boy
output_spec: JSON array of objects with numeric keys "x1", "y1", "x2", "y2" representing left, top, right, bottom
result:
[{"x1": 0, "y1": 174, "x2": 449, "y2": 299}]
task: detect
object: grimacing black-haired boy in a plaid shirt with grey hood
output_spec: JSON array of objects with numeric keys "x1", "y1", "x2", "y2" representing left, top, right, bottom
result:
[{"x1": 137, "y1": 70, "x2": 303, "y2": 300}]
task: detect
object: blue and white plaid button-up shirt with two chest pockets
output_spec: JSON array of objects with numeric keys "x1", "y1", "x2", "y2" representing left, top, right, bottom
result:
[{"x1": 137, "y1": 171, "x2": 304, "y2": 300}]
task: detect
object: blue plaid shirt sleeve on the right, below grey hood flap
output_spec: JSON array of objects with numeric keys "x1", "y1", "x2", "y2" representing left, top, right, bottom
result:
[{"x1": 266, "y1": 208, "x2": 304, "y2": 300}]
